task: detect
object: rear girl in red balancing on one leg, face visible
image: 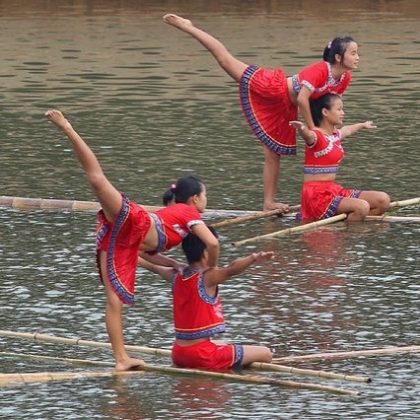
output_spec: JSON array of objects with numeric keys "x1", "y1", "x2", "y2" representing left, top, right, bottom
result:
[{"x1": 163, "y1": 14, "x2": 359, "y2": 210}]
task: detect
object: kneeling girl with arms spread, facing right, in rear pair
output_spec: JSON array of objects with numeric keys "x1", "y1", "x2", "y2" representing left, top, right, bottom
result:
[{"x1": 290, "y1": 93, "x2": 390, "y2": 221}]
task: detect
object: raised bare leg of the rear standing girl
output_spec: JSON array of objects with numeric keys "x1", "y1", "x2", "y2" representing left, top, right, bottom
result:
[{"x1": 163, "y1": 14, "x2": 248, "y2": 83}]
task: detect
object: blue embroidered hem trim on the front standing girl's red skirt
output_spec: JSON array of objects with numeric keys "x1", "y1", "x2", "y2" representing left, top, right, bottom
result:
[{"x1": 106, "y1": 195, "x2": 134, "y2": 305}]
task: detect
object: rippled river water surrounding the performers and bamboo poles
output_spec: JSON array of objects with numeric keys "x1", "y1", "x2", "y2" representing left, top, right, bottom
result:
[{"x1": 0, "y1": 0, "x2": 420, "y2": 419}]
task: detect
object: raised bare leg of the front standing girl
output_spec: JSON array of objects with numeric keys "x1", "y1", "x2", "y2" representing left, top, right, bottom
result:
[{"x1": 45, "y1": 109, "x2": 122, "y2": 222}]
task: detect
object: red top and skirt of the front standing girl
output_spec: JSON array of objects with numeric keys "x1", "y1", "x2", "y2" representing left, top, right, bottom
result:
[{"x1": 96, "y1": 195, "x2": 204, "y2": 305}]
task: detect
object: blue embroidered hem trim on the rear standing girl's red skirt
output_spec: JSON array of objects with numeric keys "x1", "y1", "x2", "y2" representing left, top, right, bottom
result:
[{"x1": 239, "y1": 66, "x2": 296, "y2": 155}]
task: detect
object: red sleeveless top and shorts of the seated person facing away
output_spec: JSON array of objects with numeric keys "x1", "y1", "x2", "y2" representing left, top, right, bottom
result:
[{"x1": 172, "y1": 267, "x2": 243, "y2": 369}]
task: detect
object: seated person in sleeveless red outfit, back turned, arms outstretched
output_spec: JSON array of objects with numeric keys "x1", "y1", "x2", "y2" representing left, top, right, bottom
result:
[{"x1": 140, "y1": 227, "x2": 273, "y2": 370}]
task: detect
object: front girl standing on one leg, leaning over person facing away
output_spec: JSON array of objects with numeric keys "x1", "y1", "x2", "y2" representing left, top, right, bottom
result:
[{"x1": 45, "y1": 110, "x2": 219, "y2": 370}]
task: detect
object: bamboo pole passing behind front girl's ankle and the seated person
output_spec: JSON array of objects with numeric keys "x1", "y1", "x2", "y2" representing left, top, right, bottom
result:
[{"x1": 0, "y1": 330, "x2": 370, "y2": 382}]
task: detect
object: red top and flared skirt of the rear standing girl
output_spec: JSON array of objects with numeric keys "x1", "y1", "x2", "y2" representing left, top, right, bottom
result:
[{"x1": 239, "y1": 61, "x2": 351, "y2": 155}]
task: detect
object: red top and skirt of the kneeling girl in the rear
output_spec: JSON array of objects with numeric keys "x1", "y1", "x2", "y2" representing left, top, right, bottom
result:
[{"x1": 301, "y1": 129, "x2": 361, "y2": 220}]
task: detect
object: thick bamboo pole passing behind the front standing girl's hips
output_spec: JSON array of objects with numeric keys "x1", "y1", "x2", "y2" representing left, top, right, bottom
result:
[{"x1": 0, "y1": 195, "x2": 259, "y2": 217}]
